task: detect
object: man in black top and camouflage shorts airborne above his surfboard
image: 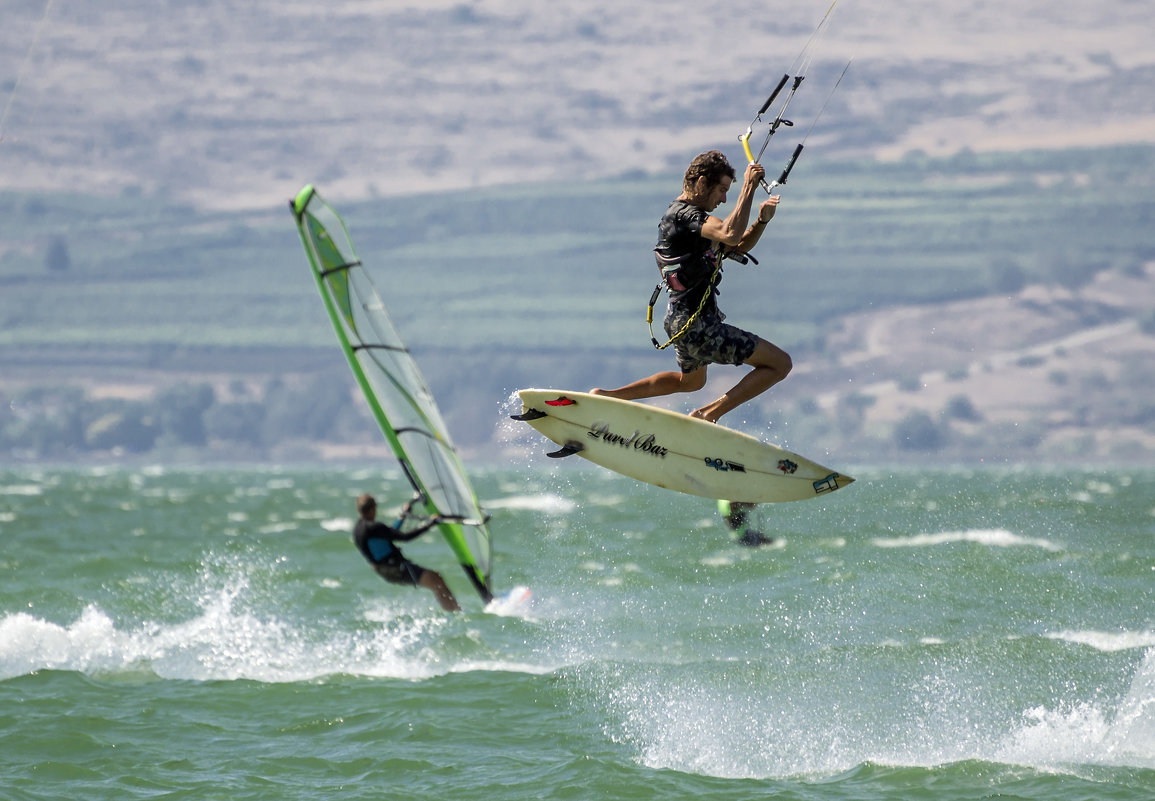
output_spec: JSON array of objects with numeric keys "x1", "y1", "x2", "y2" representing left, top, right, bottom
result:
[{"x1": 590, "y1": 150, "x2": 792, "y2": 422}]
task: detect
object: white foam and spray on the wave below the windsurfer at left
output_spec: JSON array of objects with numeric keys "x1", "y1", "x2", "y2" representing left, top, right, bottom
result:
[{"x1": 0, "y1": 576, "x2": 550, "y2": 683}]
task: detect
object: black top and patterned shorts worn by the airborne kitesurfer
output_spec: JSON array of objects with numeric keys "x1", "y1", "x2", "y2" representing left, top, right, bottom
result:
[{"x1": 654, "y1": 200, "x2": 758, "y2": 373}]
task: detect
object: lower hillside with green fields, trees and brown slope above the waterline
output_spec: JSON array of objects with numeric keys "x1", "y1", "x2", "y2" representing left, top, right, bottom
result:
[{"x1": 0, "y1": 147, "x2": 1155, "y2": 461}]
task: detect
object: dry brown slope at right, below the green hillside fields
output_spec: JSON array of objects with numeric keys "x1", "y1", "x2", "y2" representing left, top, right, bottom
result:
[{"x1": 820, "y1": 264, "x2": 1155, "y2": 459}]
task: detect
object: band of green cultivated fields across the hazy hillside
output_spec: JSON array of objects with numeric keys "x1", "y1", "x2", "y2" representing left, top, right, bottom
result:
[{"x1": 0, "y1": 147, "x2": 1155, "y2": 354}]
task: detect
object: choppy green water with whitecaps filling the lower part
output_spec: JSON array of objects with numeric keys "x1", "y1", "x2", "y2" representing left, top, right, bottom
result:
[{"x1": 0, "y1": 459, "x2": 1155, "y2": 801}]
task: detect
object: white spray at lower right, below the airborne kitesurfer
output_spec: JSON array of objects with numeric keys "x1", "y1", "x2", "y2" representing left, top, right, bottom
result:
[{"x1": 597, "y1": 649, "x2": 1155, "y2": 779}]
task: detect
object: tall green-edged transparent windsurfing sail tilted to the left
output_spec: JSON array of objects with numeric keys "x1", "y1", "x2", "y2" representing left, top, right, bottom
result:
[{"x1": 290, "y1": 186, "x2": 493, "y2": 604}]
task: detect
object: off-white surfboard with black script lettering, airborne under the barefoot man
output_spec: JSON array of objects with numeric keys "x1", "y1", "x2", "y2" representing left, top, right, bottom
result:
[{"x1": 514, "y1": 389, "x2": 854, "y2": 503}]
